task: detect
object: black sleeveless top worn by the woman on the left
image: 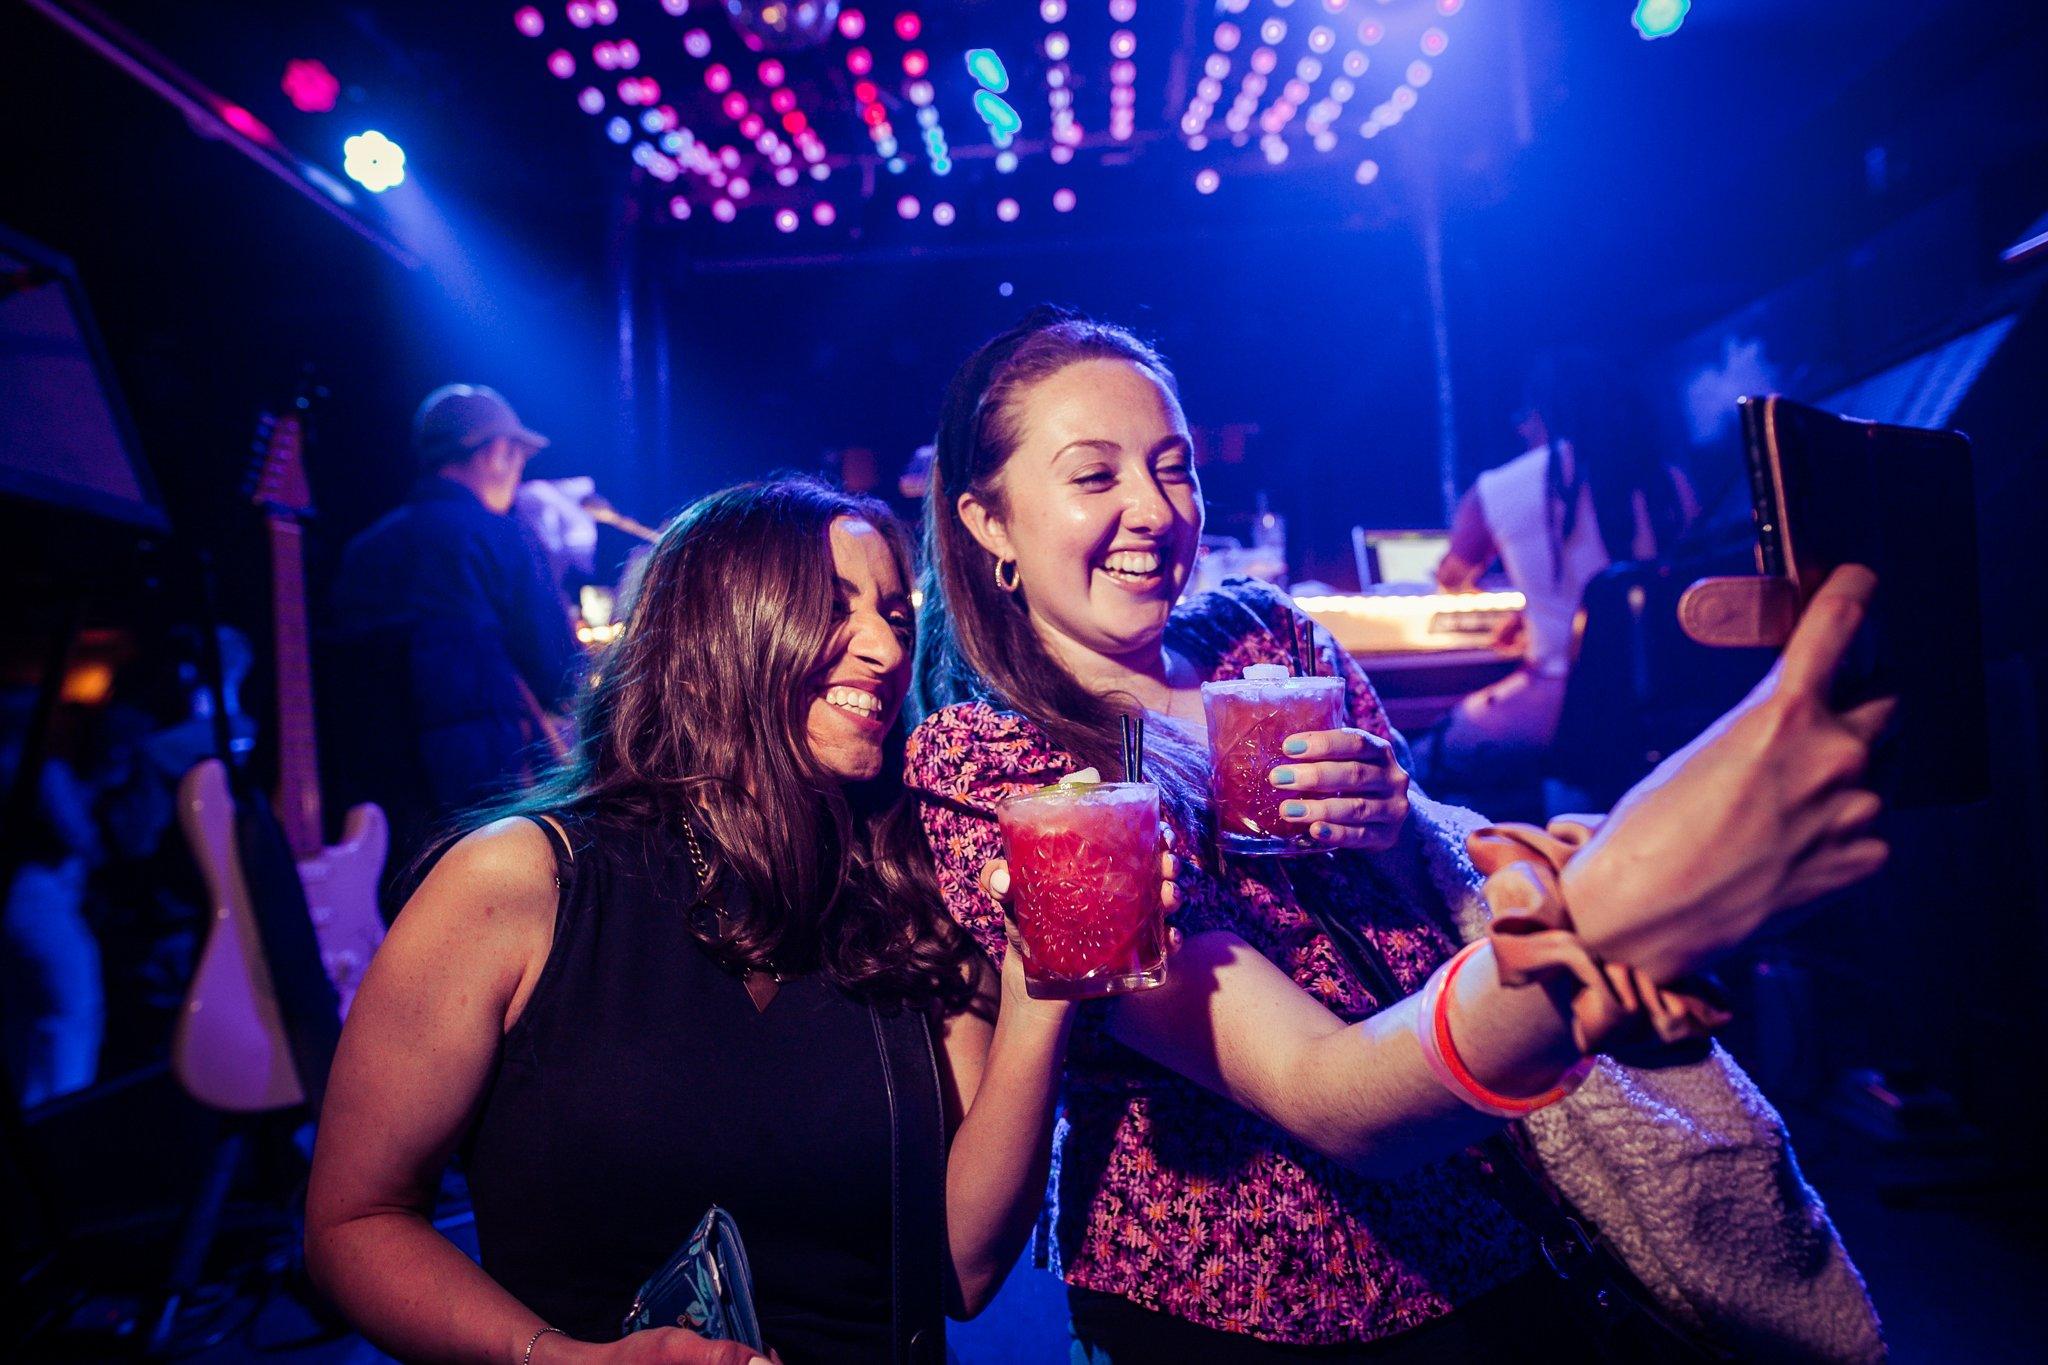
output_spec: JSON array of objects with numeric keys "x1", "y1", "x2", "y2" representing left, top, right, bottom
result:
[{"x1": 467, "y1": 821, "x2": 891, "y2": 1365}]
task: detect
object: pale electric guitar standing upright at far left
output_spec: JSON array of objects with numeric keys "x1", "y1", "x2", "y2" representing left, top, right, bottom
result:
[{"x1": 170, "y1": 401, "x2": 391, "y2": 1113}]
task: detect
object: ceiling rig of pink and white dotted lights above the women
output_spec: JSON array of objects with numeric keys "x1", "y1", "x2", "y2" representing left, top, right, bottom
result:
[{"x1": 512, "y1": 0, "x2": 1464, "y2": 239}]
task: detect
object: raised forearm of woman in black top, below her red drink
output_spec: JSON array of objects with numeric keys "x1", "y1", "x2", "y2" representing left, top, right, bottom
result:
[{"x1": 946, "y1": 993, "x2": 1073, "y2": 1318}]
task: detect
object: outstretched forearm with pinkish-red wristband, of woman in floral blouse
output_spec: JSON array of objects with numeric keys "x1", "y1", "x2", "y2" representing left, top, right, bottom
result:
[{"x1": 1112, "y1": 933, "x2": 1577, "y2": 1177}]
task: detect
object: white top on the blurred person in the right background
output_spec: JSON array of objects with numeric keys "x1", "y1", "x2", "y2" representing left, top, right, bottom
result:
[{"x1": 1477, "y1": 446, "x2": 1610, "y2": 677}]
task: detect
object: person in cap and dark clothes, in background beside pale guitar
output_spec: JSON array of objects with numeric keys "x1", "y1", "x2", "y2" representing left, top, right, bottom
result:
[{"x1": 326, "y1": 385, "x2": 578, "y2": 888}]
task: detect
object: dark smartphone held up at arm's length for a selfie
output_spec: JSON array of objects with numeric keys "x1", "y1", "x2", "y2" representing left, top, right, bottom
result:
[{"x1": 1739, "y1": 395, "x2": 1991, "y2": 806}]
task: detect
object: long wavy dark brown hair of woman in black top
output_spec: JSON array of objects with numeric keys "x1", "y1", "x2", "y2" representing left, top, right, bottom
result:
[{"x1": 494, "y1": 477, "x2": 969, "y2": 1009}]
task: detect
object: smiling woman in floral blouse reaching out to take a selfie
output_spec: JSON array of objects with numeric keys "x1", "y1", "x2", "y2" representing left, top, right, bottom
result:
[{"x1": 905, "y1": 309, "x2": 1884, "y2": 1365}]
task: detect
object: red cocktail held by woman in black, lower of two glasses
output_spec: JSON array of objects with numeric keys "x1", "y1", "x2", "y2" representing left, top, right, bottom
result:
[{"x1": 995, "y1": 782, "x2": 1165, "y2": 1001}]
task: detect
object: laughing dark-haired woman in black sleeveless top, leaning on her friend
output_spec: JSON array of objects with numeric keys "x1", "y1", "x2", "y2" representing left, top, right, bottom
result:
[{"x1": 307, "y1": 479, "x2": 1174, "y2": 1365}]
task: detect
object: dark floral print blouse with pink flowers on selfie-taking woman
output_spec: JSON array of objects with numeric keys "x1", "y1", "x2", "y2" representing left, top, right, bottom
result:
[{"x1": 907, "y1": 579, "x2": 1534, "y2": 1345}]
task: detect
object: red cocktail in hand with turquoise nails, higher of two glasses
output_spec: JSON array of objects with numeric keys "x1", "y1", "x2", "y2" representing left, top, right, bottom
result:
[{"x1": 1202, "y1": 665, "x2": 1343, "y2": 853}]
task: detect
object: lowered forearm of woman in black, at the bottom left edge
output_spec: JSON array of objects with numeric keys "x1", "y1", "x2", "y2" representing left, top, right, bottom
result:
[{"x1": 305, "y1": 1209, "x2": 565, "y2": 1365}]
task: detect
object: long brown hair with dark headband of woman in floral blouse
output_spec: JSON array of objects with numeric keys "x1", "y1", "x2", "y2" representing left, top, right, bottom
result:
[{"x1": 911, "y1": 307, "x2": 1206, "y2": 831}]
